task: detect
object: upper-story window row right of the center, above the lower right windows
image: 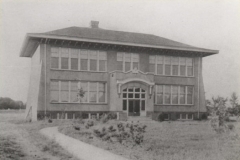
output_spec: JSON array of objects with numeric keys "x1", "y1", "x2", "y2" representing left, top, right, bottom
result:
[{"x1": 149, "y1": 55, "x2": 193, "y2": 77}]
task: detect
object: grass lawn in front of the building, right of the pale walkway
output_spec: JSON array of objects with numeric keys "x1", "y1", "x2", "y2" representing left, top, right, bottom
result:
[{"x1": 59, "y1": 121, "x2": 240, "y2": 160}]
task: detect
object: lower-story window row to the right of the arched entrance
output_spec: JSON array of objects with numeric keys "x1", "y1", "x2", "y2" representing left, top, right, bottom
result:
[{"x1": 155, "y1": 85, "x2": 194, "y2": 105}]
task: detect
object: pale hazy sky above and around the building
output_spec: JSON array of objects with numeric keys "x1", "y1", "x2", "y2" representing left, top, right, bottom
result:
[{"x1": 0, "y1": 0, "x2": 240, "y2": 102}]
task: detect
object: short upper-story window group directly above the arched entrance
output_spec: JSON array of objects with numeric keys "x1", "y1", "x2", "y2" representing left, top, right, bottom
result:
[{"x1": 117, "y1": 52, "x2": 139, "y2": 72}]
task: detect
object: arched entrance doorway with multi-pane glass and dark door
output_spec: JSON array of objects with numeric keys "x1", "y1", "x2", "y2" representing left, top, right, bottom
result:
[{"x1": 123, "y1": 87, "x2": 146, "y2": 116}]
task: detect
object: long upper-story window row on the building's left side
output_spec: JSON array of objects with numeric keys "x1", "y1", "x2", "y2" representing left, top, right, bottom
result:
[{"x1": 51, "y1": 47, "x2": 107, "y2": 72}]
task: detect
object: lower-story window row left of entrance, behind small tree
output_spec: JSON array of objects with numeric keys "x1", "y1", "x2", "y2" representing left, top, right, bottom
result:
[{"x1": 50, "y1": 80, "x2": 107, "y2": 103}]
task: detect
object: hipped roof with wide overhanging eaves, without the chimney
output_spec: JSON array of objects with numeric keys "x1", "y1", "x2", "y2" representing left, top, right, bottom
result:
[{"x1": 20, "y1": 27, "x2": 218, "y2": 57}]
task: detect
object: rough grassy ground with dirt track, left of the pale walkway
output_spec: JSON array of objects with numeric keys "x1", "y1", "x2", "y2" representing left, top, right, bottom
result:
[{"x1": 0, "y1": 111, "x2": 77, "y2": 160}]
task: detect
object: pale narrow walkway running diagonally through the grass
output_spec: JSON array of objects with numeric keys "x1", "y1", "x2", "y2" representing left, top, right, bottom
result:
[{"x1": 40, "y1": 127, "x2": 127, "y2": 160}]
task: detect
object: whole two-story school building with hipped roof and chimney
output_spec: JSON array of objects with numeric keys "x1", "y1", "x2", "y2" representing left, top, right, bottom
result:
[{"x1": 20, "y1": 21, "x2": 218, "y2": 120}]
